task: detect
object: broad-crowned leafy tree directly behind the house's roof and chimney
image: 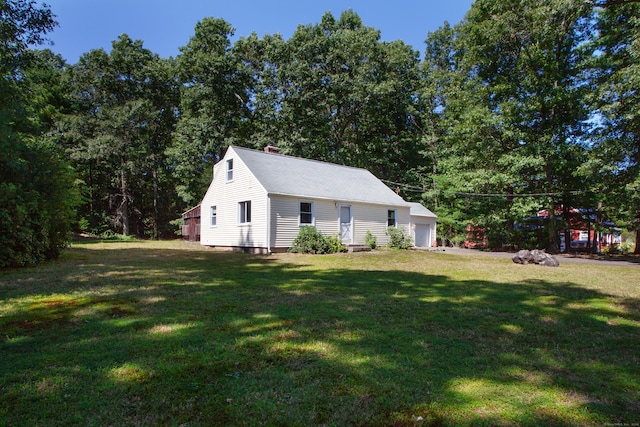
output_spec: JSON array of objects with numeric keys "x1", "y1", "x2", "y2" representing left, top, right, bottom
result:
[{"x1": 272, "y1": 11, "x2": 419, "y2": 179}]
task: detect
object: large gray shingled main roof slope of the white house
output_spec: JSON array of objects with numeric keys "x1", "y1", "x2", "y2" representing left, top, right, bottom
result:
[{"x1": 231, "y1": 146, "x2": 407, "y2": 206}]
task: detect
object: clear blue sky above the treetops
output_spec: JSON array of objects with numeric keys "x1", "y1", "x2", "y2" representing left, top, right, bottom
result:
[{"x1": 44, "y1": 0, "x2": 472, "y2": 64}]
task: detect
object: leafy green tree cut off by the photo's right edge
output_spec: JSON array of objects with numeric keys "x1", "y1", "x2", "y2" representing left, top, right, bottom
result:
[{"x1": 583, "y1": 2, "x2": 640, "y2": 253}]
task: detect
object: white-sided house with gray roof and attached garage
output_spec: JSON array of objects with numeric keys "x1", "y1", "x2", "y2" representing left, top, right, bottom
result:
[{"x1": 200, "y1": 146, "x2": 435, "y2": 253}]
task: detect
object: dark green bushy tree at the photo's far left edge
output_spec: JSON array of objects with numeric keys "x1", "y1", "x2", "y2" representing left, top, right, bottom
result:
[{"x1": 0, "y1": 0, "x2": 77, "y2": 267}]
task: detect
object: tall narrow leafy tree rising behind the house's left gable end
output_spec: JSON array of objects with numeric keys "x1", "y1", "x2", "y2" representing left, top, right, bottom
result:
[{"x1": 170, "y1": 18, "x2": 252, "y2": 204}]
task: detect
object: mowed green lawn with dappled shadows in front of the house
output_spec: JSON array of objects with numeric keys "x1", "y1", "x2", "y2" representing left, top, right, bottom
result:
[{"x1": 0, "y1": 242, "x2": 640, "y2": 426}]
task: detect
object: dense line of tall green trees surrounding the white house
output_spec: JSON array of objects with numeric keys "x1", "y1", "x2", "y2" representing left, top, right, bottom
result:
[{"x1": 0, "y1": 0, "x2": 640, "y2": 265}]
